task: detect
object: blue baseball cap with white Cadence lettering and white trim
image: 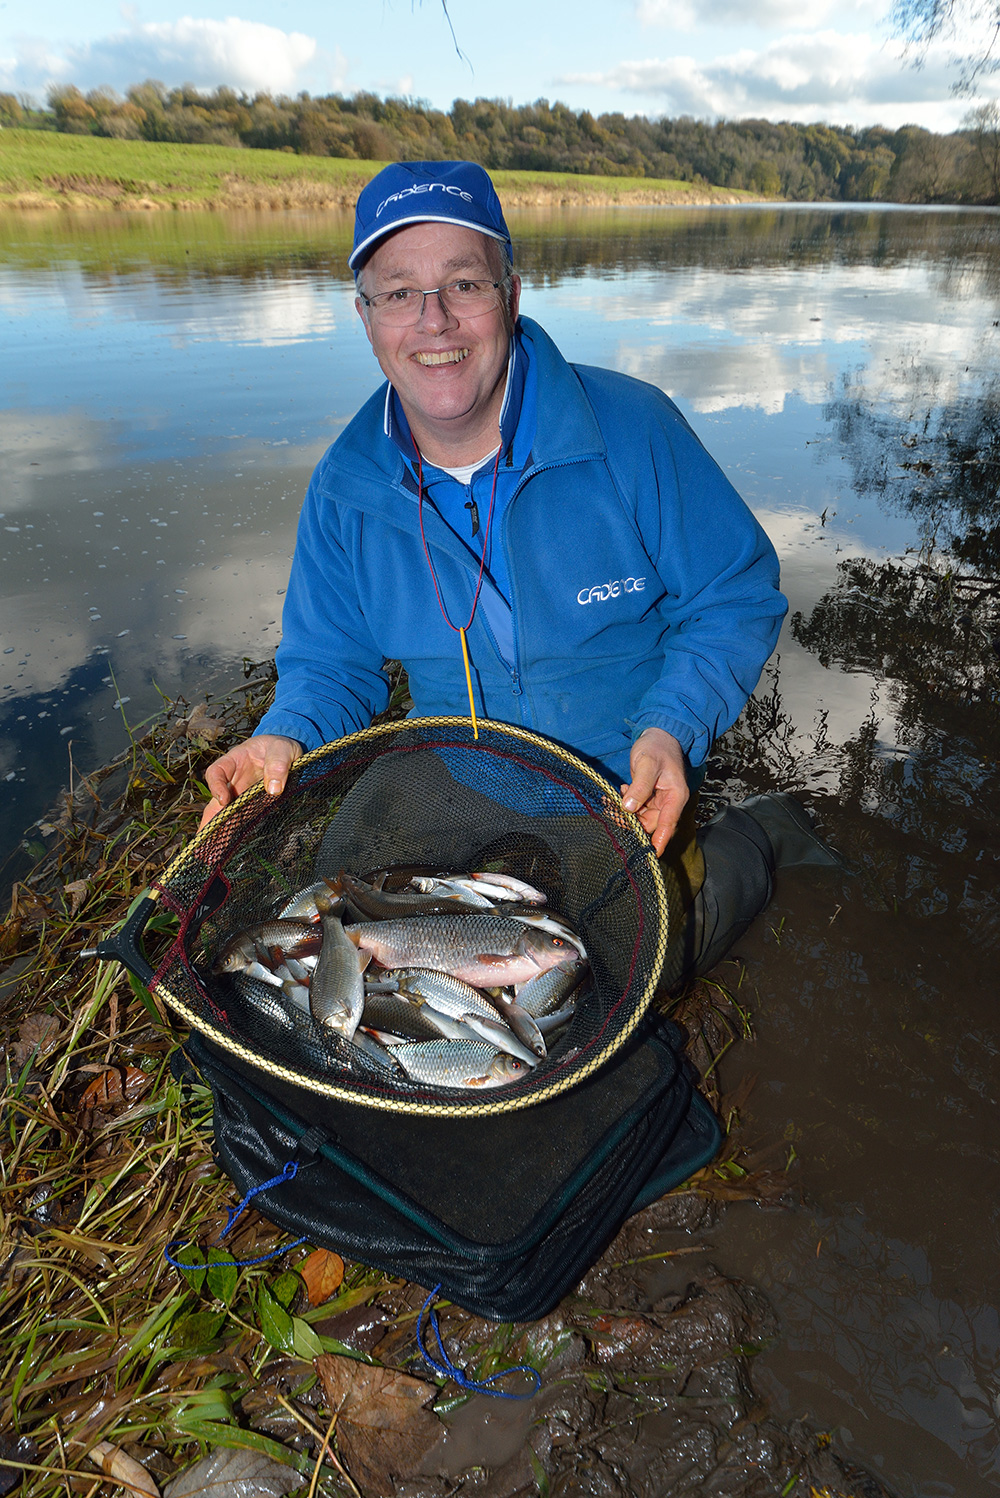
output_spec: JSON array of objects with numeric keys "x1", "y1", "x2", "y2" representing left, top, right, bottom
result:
[{"x1": 347, "y1": 162, "x2": 513, "y2": 274}]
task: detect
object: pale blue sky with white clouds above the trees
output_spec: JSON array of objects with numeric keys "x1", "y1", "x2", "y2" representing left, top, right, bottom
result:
[{"x1": 0, "y1": 0, "x2": 975, "y2": 130}]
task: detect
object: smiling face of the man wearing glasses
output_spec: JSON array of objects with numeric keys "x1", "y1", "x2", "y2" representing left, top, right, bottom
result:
[{"x1": 355, "y1": 223, "x2": 521, "y2": 464}]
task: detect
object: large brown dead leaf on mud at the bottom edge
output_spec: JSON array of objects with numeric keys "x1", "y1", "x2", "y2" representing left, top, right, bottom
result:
[{"x1": 316, "y1": 1353, "x2": 443, "y2": 1494}]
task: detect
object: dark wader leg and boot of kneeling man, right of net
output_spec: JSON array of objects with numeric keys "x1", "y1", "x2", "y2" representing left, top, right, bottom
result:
[{"x1": 671, "y1": 792, "x2": 847, "y2": 987}]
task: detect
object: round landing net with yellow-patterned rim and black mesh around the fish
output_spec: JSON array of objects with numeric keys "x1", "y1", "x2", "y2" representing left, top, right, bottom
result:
[{"x1": 154, "y1": 719, "x2": 680, "y2": 1113}]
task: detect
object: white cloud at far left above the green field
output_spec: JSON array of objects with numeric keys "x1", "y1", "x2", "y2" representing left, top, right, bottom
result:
[{"x1": 0, "y1": 16, "x2": 317, "y2": 93}]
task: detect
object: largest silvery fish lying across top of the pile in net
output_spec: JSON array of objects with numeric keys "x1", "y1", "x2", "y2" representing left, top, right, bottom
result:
[{"x1": 345, "y1": 915, "x2": 576, "y2": 984}]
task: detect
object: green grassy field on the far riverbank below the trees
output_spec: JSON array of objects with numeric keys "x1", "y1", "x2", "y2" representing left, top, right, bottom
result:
[{"x1": 0, "y1": 130, "x2": 753, "y2": 208}]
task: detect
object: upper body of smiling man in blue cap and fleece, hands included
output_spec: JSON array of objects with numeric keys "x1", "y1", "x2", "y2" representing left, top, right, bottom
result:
[{"x1": 202, "y1": 162, "x2": 786, "y2": 892}]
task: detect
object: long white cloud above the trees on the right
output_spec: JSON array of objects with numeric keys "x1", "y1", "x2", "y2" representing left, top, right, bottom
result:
[{"x1": 560, "y1": 30, "x2": 966, "y2": 129}]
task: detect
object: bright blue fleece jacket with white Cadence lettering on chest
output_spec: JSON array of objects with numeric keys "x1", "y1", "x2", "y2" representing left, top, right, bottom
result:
[{"x1": 257, "y1": 318, "x2": 787, "y2": 783}]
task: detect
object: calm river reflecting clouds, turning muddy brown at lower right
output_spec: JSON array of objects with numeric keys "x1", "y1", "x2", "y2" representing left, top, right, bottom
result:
[{"x1": 0, "y1": 205, "x2": 1000, "y2": 1498}]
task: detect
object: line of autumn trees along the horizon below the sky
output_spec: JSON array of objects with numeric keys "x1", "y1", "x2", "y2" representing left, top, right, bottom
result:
[{"x1": 0, "y1": 81, "x2": 1000, "y2": 204}]
